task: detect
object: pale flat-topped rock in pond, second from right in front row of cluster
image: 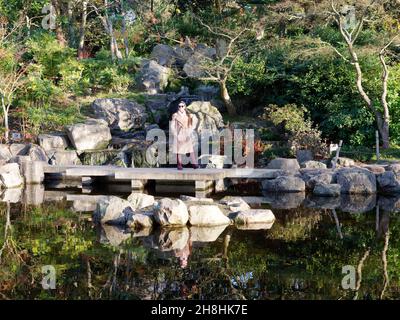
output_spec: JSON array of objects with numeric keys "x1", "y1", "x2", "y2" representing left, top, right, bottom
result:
[{"x1": 189, "y1": 205, "x2": 231, "y2": 227}]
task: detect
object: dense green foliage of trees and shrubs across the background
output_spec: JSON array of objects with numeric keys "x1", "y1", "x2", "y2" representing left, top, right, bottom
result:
[{"x1": 0, "y1": 0, "x2": 400, "y2": 146}]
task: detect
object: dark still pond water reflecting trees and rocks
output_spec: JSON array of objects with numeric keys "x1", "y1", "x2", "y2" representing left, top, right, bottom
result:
[{"x1": 0, "y1": 185, "x2": 400, "y2": 300}]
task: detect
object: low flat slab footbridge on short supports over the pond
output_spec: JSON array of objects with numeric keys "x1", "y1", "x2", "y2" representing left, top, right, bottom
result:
[{"x1": 43, "y1": 165, "x2": 278, "y2": 194}]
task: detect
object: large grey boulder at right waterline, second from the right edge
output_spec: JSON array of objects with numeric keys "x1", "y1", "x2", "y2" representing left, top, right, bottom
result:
[{"x1": 335, "y1": 168, "x2": 376, "y2": 194}]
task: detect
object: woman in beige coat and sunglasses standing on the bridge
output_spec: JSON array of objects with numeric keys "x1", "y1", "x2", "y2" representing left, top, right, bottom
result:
[{"x1": 171, "y1": 101, "x2": 199, "y2": 170}]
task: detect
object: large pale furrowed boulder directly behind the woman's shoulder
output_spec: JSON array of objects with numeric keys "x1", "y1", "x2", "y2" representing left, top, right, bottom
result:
[{"x1": 187, "y1": 101, "x2": 224, "y2": 137}]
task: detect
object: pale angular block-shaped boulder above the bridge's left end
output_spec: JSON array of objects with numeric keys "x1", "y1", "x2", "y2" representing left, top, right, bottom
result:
[{"x1": 67, "y1": 119, "x2": 112, "y2": 151}]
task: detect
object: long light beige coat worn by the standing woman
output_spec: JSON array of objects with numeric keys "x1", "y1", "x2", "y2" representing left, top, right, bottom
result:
[{"x1": 170, "y1": 111, "x2": 197, "y2": 154}]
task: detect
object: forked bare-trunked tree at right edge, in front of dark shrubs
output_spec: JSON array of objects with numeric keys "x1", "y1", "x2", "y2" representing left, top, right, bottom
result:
[{"x1": 331, "y1": 0, "x2": 399, "y2": 148}]
